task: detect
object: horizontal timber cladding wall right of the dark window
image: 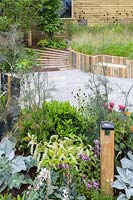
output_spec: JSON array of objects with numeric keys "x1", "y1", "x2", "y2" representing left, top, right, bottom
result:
[{"x1": 73, "y1": 0, "x2": 133, "y2": 24}]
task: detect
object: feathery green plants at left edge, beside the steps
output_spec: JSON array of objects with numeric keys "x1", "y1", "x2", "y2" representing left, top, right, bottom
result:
[{"x1": 0, "y1": 27, "x2": 36, "y2": 72}]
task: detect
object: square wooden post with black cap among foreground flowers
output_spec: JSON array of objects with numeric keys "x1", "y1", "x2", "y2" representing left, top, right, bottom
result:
[{"x1": 100, "y1": 122, "x2": 114, "y2": 196}]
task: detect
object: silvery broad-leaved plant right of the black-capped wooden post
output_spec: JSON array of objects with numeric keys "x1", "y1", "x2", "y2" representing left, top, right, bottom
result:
[{"x1": 112, "y1": 151, "x2": 133, "y2": 200}]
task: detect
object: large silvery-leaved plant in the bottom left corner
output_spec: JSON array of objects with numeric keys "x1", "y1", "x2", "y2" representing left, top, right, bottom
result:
[{"x1": 0, "y1": 137, "x2": 35, "y2": 192}]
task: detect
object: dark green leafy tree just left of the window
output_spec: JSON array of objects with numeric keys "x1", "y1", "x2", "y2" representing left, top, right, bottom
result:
[{"x1": 39, "y1": 0, "x2": 63, "y2": 37}]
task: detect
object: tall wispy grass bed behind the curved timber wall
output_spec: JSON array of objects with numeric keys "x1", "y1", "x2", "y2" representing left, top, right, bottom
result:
[{"x1": 71, "y1": 24, "x2": 133, "y2": 59}]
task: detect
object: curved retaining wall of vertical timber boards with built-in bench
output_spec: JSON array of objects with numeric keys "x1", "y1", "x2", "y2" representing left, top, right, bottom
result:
[{"x1": 69, "y1": 48, "x2": 133, "y2": 78}]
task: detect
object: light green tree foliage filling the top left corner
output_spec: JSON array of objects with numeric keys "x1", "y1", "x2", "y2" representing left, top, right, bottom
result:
[{"x1": 0, "y1": 0, "x2": 43, "y2": 31}]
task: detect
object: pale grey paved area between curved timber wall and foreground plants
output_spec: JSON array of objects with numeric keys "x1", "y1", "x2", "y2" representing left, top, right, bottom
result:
[{"x1": 21, "y1": 69, "x2": 133, "y2": 111}]
